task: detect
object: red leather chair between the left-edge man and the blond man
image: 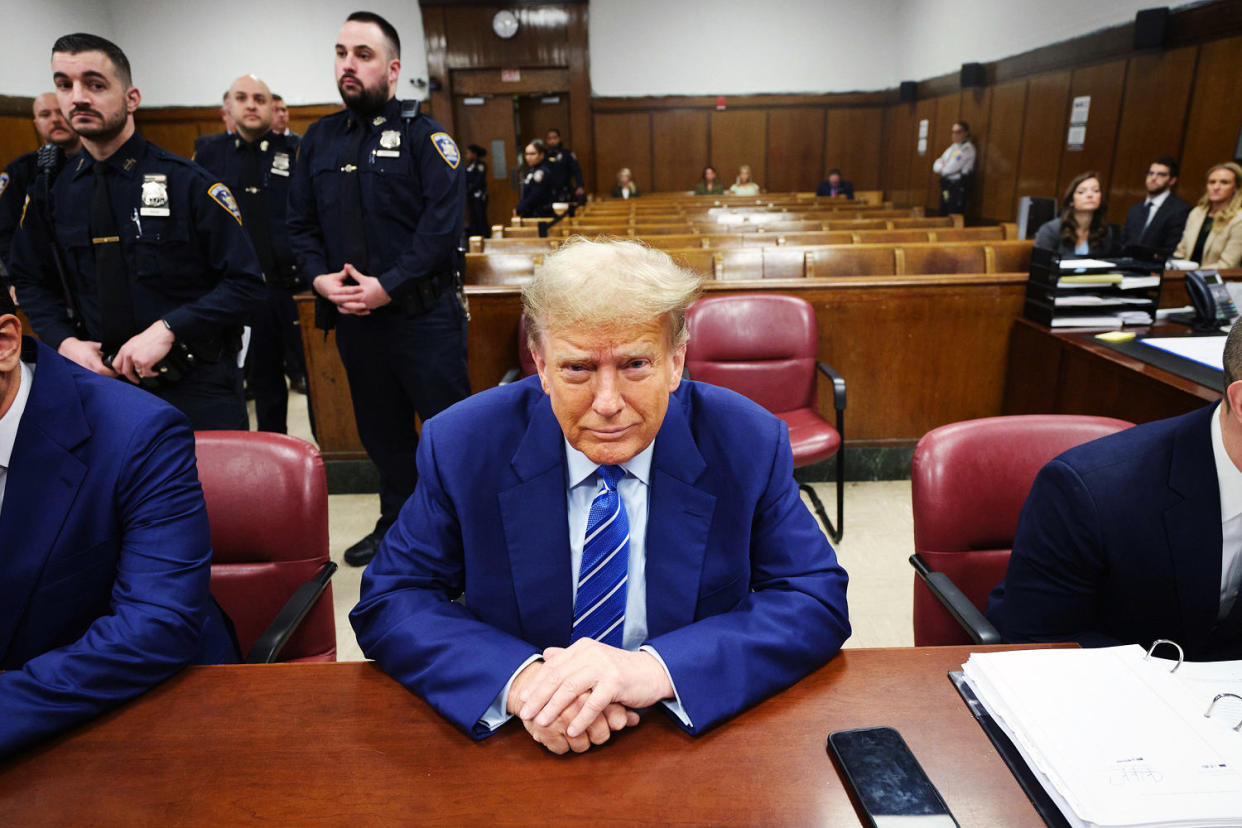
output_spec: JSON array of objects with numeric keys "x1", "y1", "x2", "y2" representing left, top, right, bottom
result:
[{"x1": 194, "y1": 431, "x2": 337, "y2": 663}]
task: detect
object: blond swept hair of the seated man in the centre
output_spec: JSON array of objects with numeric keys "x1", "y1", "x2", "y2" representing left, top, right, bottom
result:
[{"x1": 522, "y1": 236, "x2": 700, "y2": 349}]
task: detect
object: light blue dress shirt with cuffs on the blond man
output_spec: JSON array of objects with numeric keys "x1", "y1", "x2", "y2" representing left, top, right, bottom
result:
[{"x1": 481, "y1": 439, "x2": 692, "y2": 730}]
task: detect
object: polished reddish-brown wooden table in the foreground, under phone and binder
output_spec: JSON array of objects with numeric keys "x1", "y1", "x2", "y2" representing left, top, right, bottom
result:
[{"x1": 0, "y1": 647, "x2": 1042, "y2": 826}]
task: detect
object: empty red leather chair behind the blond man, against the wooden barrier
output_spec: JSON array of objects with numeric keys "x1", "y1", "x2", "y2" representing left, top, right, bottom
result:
[{"x1": 686, "y1": 294, "x2": 846, "y2": 541}]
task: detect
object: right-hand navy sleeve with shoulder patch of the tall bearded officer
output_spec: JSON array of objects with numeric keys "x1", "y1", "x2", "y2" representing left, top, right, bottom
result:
[{"x1": 370, "y1": 133, "x2": 466, "y2": 295}]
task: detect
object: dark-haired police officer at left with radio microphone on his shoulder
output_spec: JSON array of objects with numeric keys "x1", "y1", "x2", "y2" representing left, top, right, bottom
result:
[{"x1": 12, "y1": 34, "x2": 263, "y2": 431}]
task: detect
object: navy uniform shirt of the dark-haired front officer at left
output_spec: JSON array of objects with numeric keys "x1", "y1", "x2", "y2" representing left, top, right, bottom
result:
[{"x1": 12, "y1": 133, "x2": 266, "y2": 348}]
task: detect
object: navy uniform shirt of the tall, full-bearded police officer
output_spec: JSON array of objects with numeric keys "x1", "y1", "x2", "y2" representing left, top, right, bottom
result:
[{"x1": 288, "y1": 98, "x2": 466, "y2": 295}]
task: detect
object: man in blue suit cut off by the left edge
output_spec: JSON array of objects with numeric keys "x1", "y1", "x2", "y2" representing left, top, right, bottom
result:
[{"x1": 0, "y1": 284, "x2": 235, "y2": 756}]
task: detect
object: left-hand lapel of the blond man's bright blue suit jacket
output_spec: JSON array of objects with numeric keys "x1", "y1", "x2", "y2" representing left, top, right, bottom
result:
[{"x1": 497, "y1": 396, "x2": 574, "y2": 647}]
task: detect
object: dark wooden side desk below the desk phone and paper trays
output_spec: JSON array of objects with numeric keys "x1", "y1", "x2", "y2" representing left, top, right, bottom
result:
[{"x1": 1005, "y1": 319, "x2": 1221, "y2": 422}]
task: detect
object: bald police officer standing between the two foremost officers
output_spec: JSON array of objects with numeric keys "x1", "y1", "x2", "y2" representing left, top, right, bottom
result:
[{"x1": 194, "y1": 74, "x2": 306, "y2": 434}]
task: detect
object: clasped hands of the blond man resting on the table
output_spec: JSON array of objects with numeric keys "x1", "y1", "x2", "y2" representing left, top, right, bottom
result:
[{"x1": 508, "y1": 638, "x2": 673, "y2": 754}]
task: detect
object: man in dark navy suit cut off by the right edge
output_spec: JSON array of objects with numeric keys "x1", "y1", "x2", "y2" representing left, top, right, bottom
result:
[{"x1": 987, "y1": 325, "x2": 1242, "y2": 660}]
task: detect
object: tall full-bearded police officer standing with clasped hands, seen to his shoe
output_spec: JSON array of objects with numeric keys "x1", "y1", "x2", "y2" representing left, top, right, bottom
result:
[{"x1": 289, "y1": 11, "x2": 469, "y2": 566}]
